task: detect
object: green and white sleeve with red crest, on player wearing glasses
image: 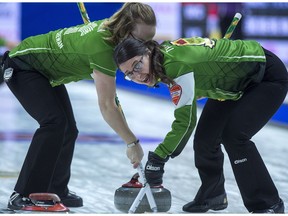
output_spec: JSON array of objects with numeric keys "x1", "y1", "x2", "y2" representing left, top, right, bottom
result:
[{"x1": 155, "y1": 73, "x2": 197, "y2": 158}]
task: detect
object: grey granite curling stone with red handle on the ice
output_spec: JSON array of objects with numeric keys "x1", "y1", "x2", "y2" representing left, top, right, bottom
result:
[{"x1": 114, "y1": 173, "x2": 171, "y2": 213}]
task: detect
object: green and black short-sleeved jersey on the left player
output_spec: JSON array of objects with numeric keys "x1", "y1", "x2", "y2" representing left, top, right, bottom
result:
[{"x1": 9, "y1": 20, "x2": 117, "y2": 86}]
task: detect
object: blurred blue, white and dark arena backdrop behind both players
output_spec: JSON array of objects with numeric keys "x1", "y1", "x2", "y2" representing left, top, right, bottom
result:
[{"x1": 0, "y1": 1, "x2": 288, "y2": 113}]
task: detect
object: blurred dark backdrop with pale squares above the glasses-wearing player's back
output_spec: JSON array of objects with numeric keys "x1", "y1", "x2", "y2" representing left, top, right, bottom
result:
[{"x1": 180, "y1": 2, "x2": 288, "y2": 66}]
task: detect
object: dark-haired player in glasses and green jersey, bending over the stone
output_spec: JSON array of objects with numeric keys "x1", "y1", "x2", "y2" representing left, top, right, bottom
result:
[{"x1": 114, "y1": 37, "x2": 288, "y2": 213}]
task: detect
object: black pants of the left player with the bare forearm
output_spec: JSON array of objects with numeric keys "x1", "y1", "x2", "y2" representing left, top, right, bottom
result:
[{"x1": 7, "y1": 70, "x2": 78, "y2": 197}]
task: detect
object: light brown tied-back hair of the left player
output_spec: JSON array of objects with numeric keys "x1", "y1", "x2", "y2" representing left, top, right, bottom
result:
[{"x1": 104, "y1": 2, "x2": 156, "y2": 44}]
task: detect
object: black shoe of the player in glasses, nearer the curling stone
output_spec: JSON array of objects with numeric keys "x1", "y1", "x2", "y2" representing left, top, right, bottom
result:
[{"x1": 182, "y1": 193, "x2": 228, "y2": 213}]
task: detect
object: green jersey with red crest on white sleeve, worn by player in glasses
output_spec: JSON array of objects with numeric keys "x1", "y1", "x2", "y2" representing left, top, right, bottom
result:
[{"x1": 155, "y1": 37, "x2": 266, "y2": 158}]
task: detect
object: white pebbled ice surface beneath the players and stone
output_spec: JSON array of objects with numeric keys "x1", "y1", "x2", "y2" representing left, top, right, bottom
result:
[{"x1": 0, "y1": 81, "x2": 288, "y2": 214}]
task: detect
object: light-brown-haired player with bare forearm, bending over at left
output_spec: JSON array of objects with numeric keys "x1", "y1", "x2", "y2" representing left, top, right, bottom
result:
[{"x1": 3, "y1": 3, "x2": 156, "y2": 209}]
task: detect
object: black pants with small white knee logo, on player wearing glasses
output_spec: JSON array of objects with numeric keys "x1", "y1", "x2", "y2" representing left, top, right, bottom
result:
[{"x1": 194, "y1": 50, "x2": 288, "y2": 212}]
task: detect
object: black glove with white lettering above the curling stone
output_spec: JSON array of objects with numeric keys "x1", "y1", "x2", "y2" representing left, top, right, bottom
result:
[{"x1": 145, "y1": 151, "x2": 169, "y2": 187}]
